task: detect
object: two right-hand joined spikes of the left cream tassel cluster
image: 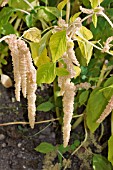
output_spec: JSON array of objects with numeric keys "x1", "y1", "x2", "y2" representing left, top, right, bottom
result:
[{"x1": 18, "y1": 39, "x2": 37, "y2": 128}]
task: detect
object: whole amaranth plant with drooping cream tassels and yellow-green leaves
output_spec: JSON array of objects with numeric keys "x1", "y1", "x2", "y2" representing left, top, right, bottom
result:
[{"x1": 0, "y1": 0, "x2": 113, "y2": 164}]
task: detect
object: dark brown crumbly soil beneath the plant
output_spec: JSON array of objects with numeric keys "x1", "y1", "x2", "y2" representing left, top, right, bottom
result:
[{"x1": 0, "y1": 64, "x2": 110, "y2": 170}]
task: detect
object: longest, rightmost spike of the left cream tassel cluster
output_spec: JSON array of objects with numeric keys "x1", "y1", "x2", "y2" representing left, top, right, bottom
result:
[{"x1": 18, "y1": 39, "x2": 37, "y2": 128}]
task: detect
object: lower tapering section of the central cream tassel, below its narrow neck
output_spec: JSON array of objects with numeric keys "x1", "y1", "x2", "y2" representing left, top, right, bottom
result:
[{"x1": 63, "y1": 79, "x2": 75, "y2": 147}]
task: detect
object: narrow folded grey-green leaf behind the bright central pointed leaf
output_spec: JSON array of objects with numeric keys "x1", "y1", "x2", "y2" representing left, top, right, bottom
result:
[{"x1": 38, "y1": 30, "x2": 51, "y2": 56}]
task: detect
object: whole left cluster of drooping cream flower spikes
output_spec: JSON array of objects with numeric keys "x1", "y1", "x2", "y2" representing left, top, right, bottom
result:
[{"x1": 5, "y1": 34, "x2": 37, "y2": 128}]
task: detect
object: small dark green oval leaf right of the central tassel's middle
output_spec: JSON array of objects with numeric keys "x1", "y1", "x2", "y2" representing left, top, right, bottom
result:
[{"x1": 79, "y1": 90, "x2": 89, "y2": 106}]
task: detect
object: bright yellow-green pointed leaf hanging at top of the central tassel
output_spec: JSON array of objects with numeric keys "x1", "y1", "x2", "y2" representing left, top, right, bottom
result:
[{"x1": 49, "y1": 31, "x2": 67, "y2": 62}]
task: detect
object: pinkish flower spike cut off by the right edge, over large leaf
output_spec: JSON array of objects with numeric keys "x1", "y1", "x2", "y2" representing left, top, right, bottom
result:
[{"x1": 97, "y1": 96, "x2": 113, "y2": 123}]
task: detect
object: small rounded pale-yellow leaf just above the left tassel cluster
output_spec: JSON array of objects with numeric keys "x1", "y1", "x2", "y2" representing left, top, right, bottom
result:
[{"x1": 23, "y1": 27, "x2": 41, "y2": 43}]
